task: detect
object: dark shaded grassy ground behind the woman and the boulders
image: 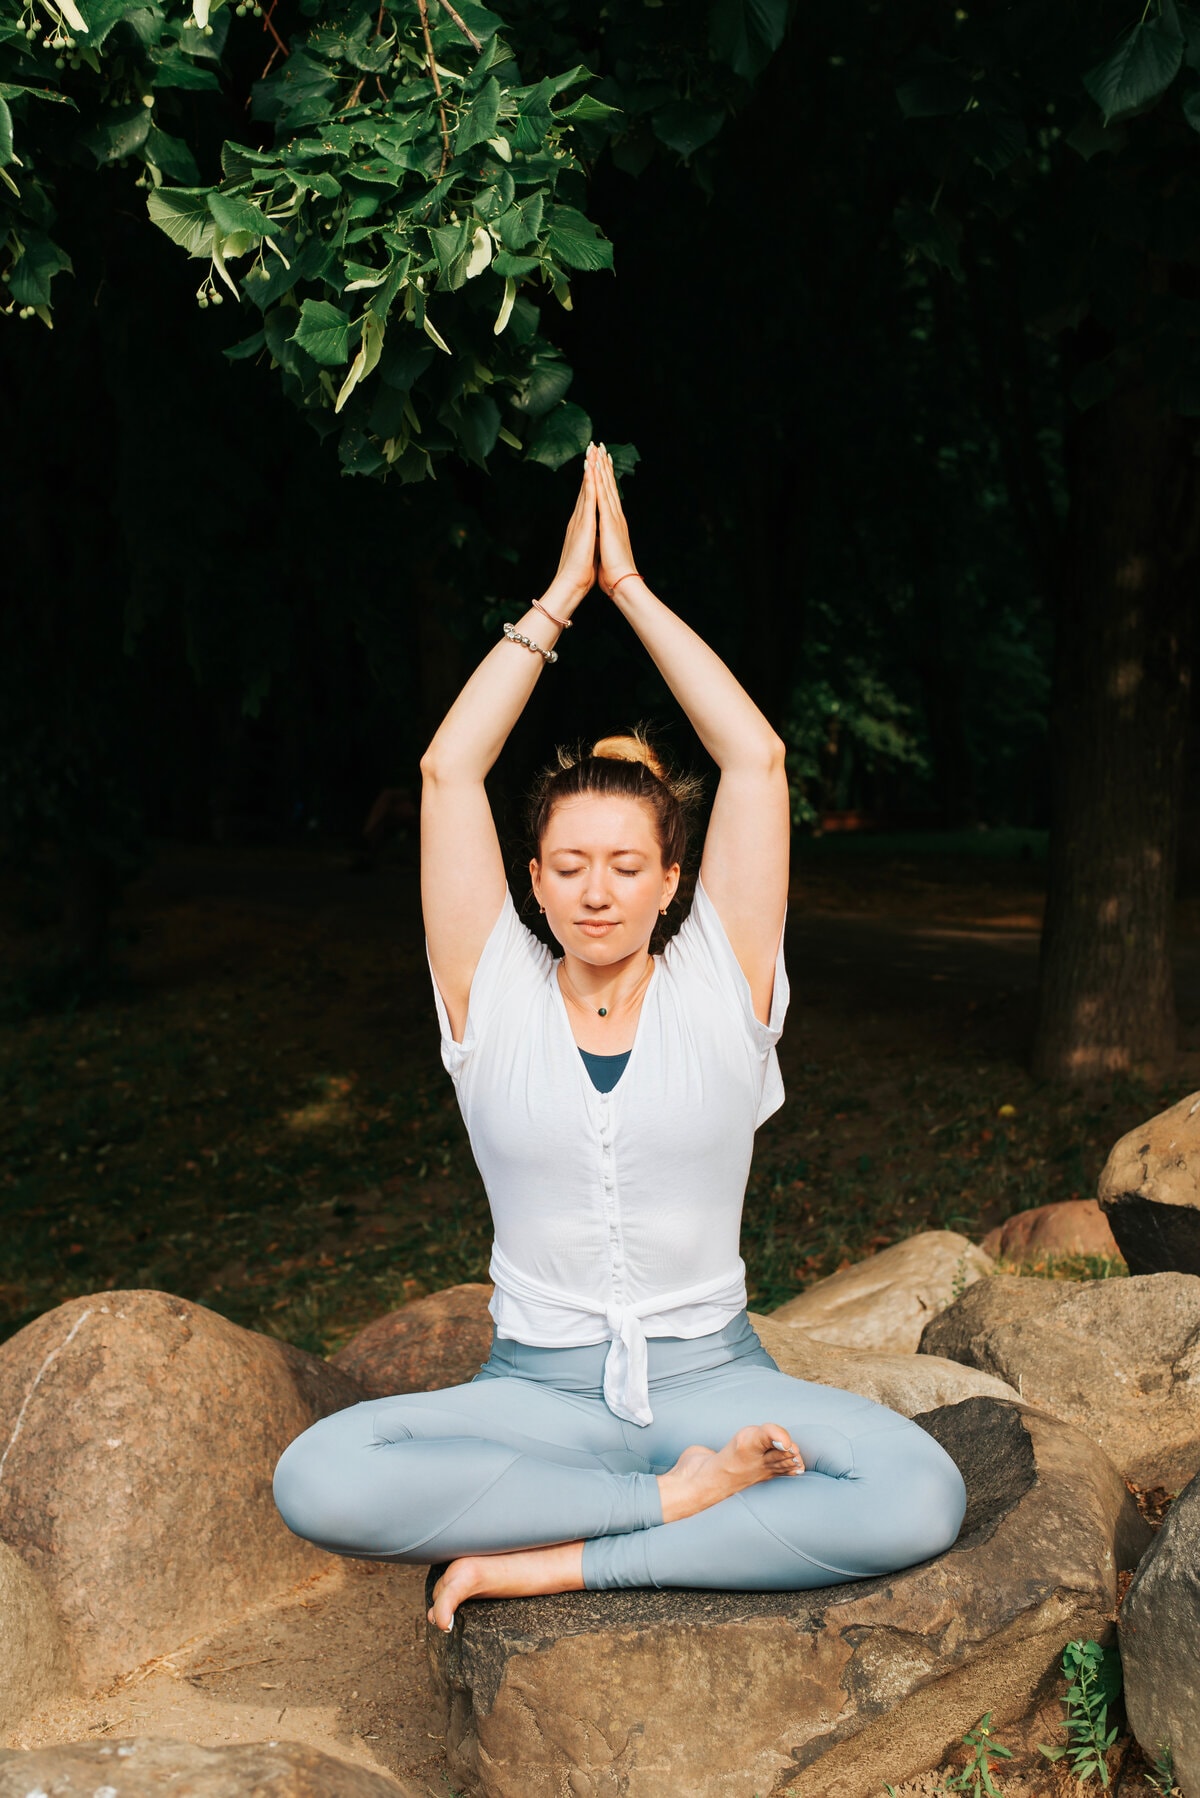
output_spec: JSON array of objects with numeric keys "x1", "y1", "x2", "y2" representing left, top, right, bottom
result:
[{"x1": 0, "y1": 843, "x2": 1200, "y2": 1352}]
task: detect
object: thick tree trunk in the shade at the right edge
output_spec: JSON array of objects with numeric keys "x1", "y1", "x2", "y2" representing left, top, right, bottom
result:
[{"x1": 1033, "y1": 387, "x2": 1200, "y2": 1084}]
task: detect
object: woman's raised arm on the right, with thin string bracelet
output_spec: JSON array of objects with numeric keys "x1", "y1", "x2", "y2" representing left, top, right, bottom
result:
[{"x1": 597, "y1": 444, "x2": 792, "y2": 1023}]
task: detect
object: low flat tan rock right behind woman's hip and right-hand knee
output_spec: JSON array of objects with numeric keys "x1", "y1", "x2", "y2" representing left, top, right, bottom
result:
[{"x1": 750, "y1": 1314, "x2": 1018, "y2": 1417}]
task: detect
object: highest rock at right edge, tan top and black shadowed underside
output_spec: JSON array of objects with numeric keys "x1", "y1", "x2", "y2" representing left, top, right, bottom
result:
[{"x1": 1099, "y1": 1093, "x2": 1200, "y2": 1275}]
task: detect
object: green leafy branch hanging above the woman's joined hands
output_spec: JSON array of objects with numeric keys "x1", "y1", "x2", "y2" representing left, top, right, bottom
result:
[{"x1": 0, "y1": 0, "x2": 793, "y2": 482}]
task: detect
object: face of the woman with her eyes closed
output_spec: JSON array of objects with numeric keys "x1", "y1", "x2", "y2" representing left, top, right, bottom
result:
[{"x1": 529, "y1": 793, "x2": 680, "y2": 967}]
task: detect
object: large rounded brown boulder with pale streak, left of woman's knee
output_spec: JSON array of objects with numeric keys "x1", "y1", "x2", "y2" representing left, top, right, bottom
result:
[{"x1": 0, "y1": 1291, "x2": 362, "y2": 1688}]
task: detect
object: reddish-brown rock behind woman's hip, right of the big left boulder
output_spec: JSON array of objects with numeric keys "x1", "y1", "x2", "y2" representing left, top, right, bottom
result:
[{"x1": 331, "y1": 1284, "x2": 493, "y2": 1399}]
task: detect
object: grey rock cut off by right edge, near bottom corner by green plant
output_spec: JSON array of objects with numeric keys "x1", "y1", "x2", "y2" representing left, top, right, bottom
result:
[{"x1": 1117, "y1": 1478, "x2": 1200, "y2": 1798}]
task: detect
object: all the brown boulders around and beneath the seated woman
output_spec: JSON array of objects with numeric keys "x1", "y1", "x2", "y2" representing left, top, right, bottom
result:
[{"x1": 0, "y1": 1095, "x2": 1200, "y2": 1798}]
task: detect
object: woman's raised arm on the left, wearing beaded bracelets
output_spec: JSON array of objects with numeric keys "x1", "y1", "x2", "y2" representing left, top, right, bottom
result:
[{"x1": 421, "y1": 457, "x2": 596, "y2": 1041}]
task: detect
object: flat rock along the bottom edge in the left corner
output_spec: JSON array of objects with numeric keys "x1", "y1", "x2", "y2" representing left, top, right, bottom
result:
[{"x1": 0, "y1": 1735, "x2": 403, "y2": 1798}]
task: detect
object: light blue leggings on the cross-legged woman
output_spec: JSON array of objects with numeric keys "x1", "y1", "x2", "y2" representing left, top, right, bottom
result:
[{"x1": 275, "y1": 1313, "x2": 966, "y2": 1591}]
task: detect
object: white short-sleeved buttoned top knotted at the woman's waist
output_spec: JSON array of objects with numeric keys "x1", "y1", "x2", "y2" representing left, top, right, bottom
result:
[{"x1": 434, "y1": 883, "x2": 788, "y2": 1424}]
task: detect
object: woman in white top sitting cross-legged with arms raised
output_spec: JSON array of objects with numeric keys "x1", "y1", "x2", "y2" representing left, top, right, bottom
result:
[{"x1": 275, "y1": 444, "x2": 966, "y2": 1629}]
